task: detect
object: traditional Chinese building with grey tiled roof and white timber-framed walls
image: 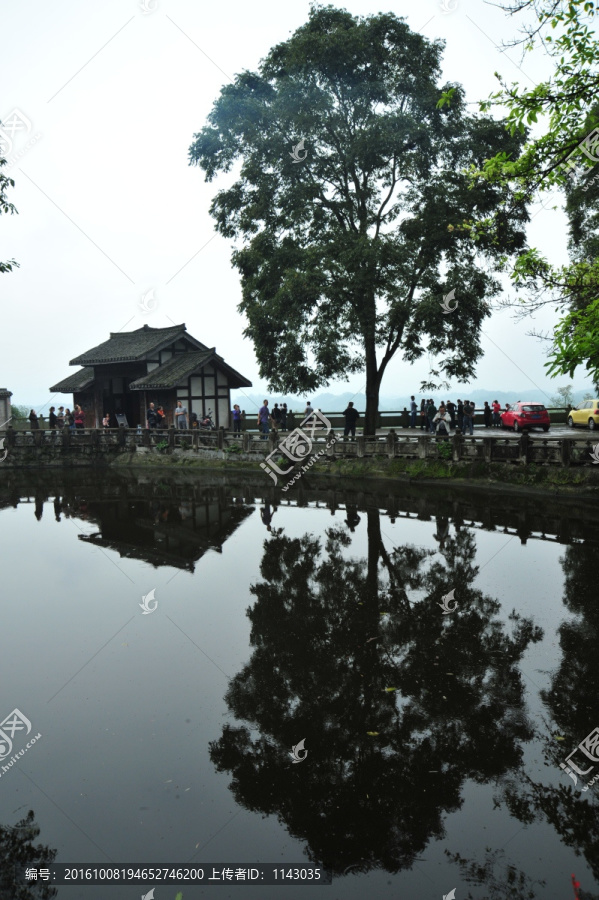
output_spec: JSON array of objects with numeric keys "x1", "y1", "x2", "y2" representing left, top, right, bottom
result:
[{"x1": 50, "y1": 325, "x2": 252, "y2": 428}]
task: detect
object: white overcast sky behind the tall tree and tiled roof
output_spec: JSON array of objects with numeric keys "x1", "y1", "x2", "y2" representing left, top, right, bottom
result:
[{"x1": 0, "y1": 0, "x2": 585, "y2": 407}]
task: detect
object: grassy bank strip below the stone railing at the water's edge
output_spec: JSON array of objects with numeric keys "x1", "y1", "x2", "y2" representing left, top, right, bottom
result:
[{"x1": 111, "y1": 453, "x2": 599, "y2": 494}]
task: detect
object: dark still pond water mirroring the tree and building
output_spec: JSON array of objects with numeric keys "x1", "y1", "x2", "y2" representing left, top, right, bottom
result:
[{"x1": 0, "y1": 471, "x2": 599, "y2": 900}]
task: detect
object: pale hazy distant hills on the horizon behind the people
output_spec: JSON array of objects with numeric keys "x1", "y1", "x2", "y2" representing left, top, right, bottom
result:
[{"x1": 231, "y1": 387, "x2": 592, "y2": 415}]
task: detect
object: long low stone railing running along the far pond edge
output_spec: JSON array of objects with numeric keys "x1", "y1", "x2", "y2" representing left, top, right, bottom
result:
[{"x1": 0, "y1": 428, "x2": 599, "y2": 471}]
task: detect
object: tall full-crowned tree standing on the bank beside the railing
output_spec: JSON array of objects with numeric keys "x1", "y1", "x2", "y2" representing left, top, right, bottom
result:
[{"x1": 190, "y1": 6, "x2": 527, "y2": 433}]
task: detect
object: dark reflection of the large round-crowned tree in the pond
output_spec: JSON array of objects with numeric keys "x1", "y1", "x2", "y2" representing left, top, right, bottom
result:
[{"x1": 210, "y1": 509, "x2": 542, "y2": 875}]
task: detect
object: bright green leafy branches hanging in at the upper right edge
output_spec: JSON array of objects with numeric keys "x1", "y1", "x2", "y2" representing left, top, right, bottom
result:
[{"x1": 482, "y1": 0, "x2": 599, "y2": 389}]
